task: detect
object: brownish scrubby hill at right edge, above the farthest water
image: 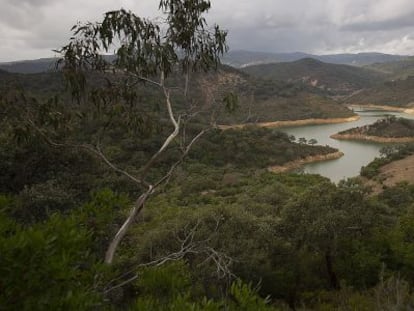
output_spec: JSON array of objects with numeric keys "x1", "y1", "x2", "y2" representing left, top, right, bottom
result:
[{"x1": 345, "y1": 76, "x2": 414, "y2": 108}]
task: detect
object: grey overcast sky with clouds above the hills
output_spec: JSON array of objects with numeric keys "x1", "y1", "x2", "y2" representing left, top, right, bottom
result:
[{"x1": 0, "y1": 0, "x2": 414, "y2": 61}]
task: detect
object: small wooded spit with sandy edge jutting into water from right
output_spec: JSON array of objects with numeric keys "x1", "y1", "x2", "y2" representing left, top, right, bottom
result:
[{"x1": 331, "y1": 116, "x2": 414, "y2": 143}]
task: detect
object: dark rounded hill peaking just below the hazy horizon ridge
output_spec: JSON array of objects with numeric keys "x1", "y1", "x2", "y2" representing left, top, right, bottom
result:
[{"x1": 242, "y1": 58, "x2": 386, "y2": 94}]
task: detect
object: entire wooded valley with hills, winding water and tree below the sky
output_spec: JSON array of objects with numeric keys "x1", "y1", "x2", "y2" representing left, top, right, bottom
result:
[{"x1": 0, "y1": 18, "x2": 414, "y2": 311}]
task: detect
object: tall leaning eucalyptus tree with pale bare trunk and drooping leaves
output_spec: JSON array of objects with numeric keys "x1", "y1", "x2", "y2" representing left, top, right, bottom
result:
[{"x1": 4, "y1": 0, "x2": 230, "y2": 264}]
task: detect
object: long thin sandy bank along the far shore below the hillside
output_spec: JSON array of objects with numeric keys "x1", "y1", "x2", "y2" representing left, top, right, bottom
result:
[{"x1": 217, "y1": 115, "x2": 360, "y2": 130}]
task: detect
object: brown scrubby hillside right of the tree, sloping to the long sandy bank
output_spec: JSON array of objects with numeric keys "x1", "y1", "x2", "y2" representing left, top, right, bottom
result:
[{"x1": 196, "y1": 66, "x2": 353, "y2": 124}]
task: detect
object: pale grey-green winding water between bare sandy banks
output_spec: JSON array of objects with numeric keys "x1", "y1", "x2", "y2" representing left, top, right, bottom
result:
[{"x1": 280, "y1": 111, "x2": 414, "y2": 182}]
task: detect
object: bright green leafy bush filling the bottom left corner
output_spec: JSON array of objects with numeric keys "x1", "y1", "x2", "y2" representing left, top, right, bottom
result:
[{"x1": 0, "y1": 207, "x2": 101, "y2": 310}]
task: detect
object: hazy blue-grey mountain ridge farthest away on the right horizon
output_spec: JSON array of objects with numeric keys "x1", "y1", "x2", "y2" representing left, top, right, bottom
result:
[{"x1": 222, "y1": 50, "x2": 407, "y2": 68}]
